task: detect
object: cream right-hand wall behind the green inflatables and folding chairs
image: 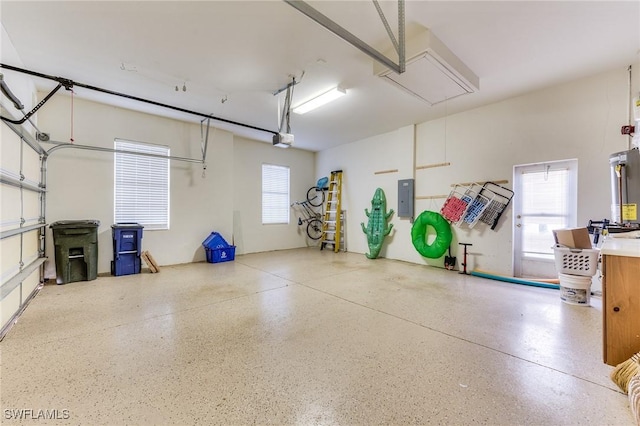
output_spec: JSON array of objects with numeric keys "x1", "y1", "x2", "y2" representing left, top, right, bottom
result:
[{"x1": 317, "y1": 66, "x2": 640, "y2": 274}]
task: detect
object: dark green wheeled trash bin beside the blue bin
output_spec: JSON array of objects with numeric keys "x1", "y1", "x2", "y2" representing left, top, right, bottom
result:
[{"x1": 50, "y1": 220, "x2": 100, "y2": 284}]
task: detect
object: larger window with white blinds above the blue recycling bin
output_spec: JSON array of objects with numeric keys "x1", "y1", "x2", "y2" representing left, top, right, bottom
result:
[{"x1": 114, "y1": 139, "x2": 170, "y2": 230}]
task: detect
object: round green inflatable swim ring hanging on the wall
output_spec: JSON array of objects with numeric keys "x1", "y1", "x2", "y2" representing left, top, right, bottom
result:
[{"x1": 411, "y1": 210, "x2": 452, "y2": 259}]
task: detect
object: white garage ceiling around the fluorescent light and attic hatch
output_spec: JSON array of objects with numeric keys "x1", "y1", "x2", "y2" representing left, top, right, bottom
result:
[{"x1": 0, "y1": 0, "x2": 640, "y2": 151}]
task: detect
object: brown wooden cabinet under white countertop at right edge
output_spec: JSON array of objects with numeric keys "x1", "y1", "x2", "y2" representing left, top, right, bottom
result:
[{"x1": 602, "y1": 254, "x2": 640, "y2": 366}]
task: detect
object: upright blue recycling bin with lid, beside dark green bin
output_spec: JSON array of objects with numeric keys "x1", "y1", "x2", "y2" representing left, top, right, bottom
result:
[{"x1": 111, "y1": 223, "x2": 144, "y2": 276}]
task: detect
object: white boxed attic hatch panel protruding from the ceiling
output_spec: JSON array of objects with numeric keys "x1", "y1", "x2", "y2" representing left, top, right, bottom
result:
[{"x1": 373, "y1": 28, "x2": 480, "y2": 105}]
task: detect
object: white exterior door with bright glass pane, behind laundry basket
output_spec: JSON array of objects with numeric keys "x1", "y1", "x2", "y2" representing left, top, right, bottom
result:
[{"x1": 513, "y1": 160, "x2": 578, "y2": 278}]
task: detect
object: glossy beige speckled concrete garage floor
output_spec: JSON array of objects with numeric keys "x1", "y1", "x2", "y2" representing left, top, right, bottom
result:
[{"x1": 0, "y1": 249, "x2": 633, "y2": 425}]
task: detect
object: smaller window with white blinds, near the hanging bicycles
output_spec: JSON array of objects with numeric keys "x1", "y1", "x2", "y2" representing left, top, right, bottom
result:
[{"x1": 262, "y1": 164, "x2": 289, "y2": 225}]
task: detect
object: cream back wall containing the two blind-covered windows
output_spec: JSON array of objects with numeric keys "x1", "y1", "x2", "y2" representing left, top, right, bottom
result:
[{"x1": 40, "y1": 96, "x2": 314, "y2": 278}]
